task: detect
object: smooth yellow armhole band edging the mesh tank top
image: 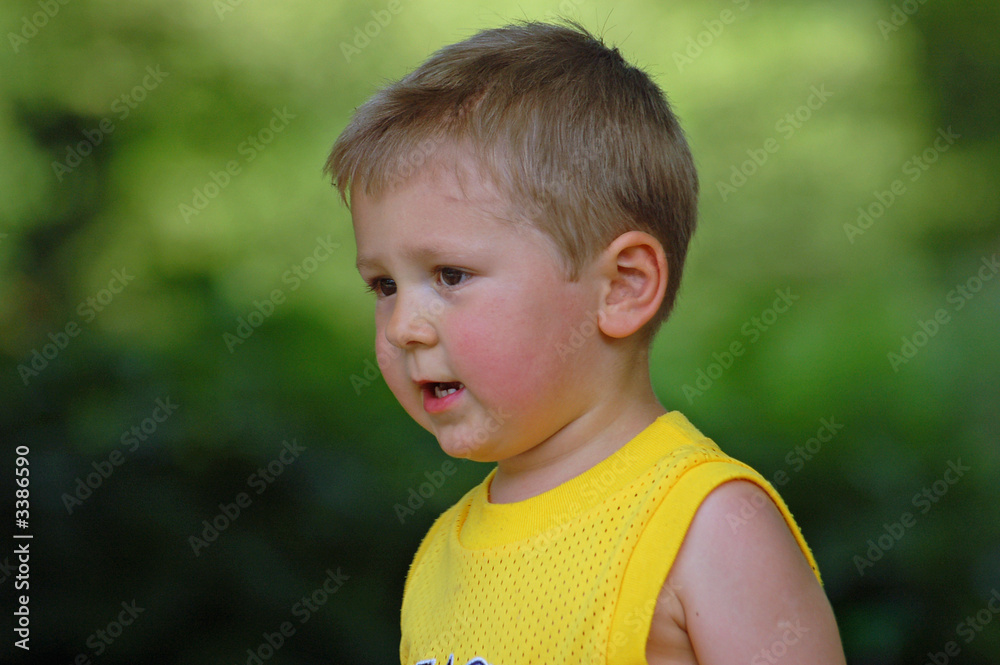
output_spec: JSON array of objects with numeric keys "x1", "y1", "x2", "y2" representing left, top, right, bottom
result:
[{"x1": 607, "y1": 460, "x2": 823, "y2": 665}]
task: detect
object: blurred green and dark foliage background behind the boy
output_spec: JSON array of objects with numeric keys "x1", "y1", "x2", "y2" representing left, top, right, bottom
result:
[{"x1": 0, "y1": 0, "x2": 1000, "y2": 665}]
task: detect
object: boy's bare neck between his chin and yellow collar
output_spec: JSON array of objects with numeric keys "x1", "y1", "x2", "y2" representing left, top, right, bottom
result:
[{"x1": 489, "y1": 383, "x2": 667, "y2": 503}]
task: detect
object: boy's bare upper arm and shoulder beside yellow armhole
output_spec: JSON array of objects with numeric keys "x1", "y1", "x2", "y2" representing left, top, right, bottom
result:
[{"x1": 653, "y1": 480, "x2": 845, "y2": 665}]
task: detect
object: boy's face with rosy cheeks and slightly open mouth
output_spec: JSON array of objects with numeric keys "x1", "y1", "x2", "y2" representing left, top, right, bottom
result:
[{"x1": 352, "y1": 154, "x2": 600, "y2": 462}]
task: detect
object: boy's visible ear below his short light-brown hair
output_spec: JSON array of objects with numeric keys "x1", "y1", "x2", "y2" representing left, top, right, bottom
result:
[{"x1": 597, "y1": 231, "x2": 667, "y2": 338}]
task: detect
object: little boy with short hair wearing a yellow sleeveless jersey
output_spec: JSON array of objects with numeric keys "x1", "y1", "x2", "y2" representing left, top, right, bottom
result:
[{"x1": 327, "y1": 22, "x2": 844, "y2": 665}]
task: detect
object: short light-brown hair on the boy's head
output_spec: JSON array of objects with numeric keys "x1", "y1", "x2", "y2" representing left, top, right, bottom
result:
[{"x1": 326, "y1": 20, "x2": 698, "y2": 341}]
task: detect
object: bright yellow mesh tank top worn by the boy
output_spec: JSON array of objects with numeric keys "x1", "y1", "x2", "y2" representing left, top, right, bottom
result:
[{"x1": 399, "y1": 411, "x2": 819, "y2": 665}]
